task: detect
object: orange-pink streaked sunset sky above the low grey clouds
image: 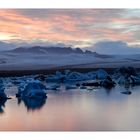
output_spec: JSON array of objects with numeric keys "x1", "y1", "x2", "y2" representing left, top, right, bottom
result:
[{"x1": 0, "y1": 9, "x2": 140, "y2": 53}]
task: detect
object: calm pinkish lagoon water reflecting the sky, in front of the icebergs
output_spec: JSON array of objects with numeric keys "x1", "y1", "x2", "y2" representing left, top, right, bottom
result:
[{"x1": 0, "y1": 86, "x2": 140, "y2": 131}]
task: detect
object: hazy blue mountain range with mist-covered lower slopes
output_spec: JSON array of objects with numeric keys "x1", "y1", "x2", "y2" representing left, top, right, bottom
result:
[{"x1": 0, "y1": 46, "x2": 140, "y2": 70}]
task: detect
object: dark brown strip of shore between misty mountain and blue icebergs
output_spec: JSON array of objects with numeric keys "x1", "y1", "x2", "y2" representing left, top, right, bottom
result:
[{"x1": 0, "y1": 67, "x2": 140, "y2": 77}]
